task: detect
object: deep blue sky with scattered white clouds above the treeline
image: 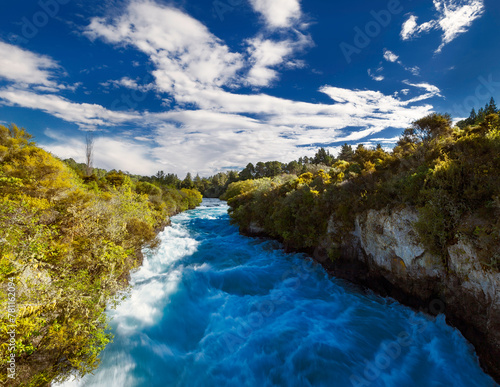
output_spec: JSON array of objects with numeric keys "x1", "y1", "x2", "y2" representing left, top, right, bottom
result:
[{"x1": 0, "y1": 0, "x2": 500, "y2": 177}]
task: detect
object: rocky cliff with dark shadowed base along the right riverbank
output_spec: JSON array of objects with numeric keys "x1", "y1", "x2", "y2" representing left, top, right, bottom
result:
[{"x1": 245, "y1": 208, "x2": 500, "y2": 382}]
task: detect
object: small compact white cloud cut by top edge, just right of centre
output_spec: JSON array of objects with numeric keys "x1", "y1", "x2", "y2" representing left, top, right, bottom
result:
[{"x1": 250, "y1": 0, "x2": 302, "y2": 28}]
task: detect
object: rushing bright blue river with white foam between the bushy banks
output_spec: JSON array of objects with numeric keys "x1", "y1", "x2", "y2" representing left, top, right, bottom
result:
[{"x1": 60, "y1": 199, "x2": 497, "y2": 387}]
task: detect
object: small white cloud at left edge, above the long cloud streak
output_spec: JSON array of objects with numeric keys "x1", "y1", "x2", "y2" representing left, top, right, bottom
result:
[{"x1": 0, "y1": 41, "x2": 59, "y2": 90}]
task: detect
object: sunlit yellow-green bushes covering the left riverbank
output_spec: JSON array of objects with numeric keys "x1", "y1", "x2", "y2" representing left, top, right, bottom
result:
[{"x1": 0, "y1": 125, "x2": 201, "y2": 386}]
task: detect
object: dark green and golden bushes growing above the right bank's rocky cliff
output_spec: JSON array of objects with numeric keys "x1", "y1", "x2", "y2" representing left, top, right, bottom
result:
[{"x1": 223, "y1": 108, "x2": 500, "y2": 270}]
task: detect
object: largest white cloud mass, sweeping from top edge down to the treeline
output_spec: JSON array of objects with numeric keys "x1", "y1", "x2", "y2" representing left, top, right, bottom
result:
[{"x1": 0, "y1": 1, "x2": 439, "y2": 175}]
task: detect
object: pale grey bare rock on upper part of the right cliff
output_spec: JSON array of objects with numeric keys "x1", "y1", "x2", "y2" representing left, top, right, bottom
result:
[{"x1": 348, "y1": 208, "x2": 500, "y2": 303}]
